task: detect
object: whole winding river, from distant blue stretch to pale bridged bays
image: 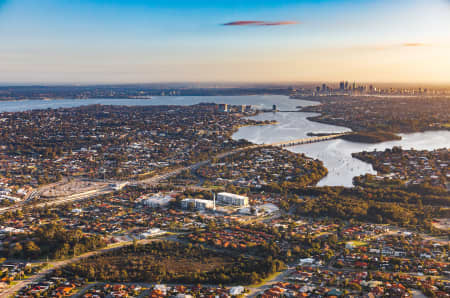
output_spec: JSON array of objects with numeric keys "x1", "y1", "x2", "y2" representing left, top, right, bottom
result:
[{"x1": 0, "y1": 95, "x2": 450, "y2": 186}]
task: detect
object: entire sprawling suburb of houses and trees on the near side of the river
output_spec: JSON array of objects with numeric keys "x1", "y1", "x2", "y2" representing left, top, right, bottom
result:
[{"x1": 0, "y1": 104, "x2": 450, "y2": 298}]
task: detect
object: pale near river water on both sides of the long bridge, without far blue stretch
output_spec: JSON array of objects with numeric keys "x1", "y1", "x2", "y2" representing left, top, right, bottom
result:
[{"x1": 233, "y1": 113, "x2": 450, "y2": 186}]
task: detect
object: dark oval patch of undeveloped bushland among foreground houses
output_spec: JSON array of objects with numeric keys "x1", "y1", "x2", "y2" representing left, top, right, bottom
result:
[{"x1": 56, "y1": 241, "x2": 282, "y2": 284}]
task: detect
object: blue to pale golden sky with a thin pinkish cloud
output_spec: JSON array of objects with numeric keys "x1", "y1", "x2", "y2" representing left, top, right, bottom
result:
[{"x1": 0, "y1": 0, "x2": 450, "y2": 84}]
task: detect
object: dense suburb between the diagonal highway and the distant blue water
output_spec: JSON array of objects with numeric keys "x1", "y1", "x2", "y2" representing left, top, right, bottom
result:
[{"x1": 0, "y1": 104, "x2": 268, "y2": 192}]
